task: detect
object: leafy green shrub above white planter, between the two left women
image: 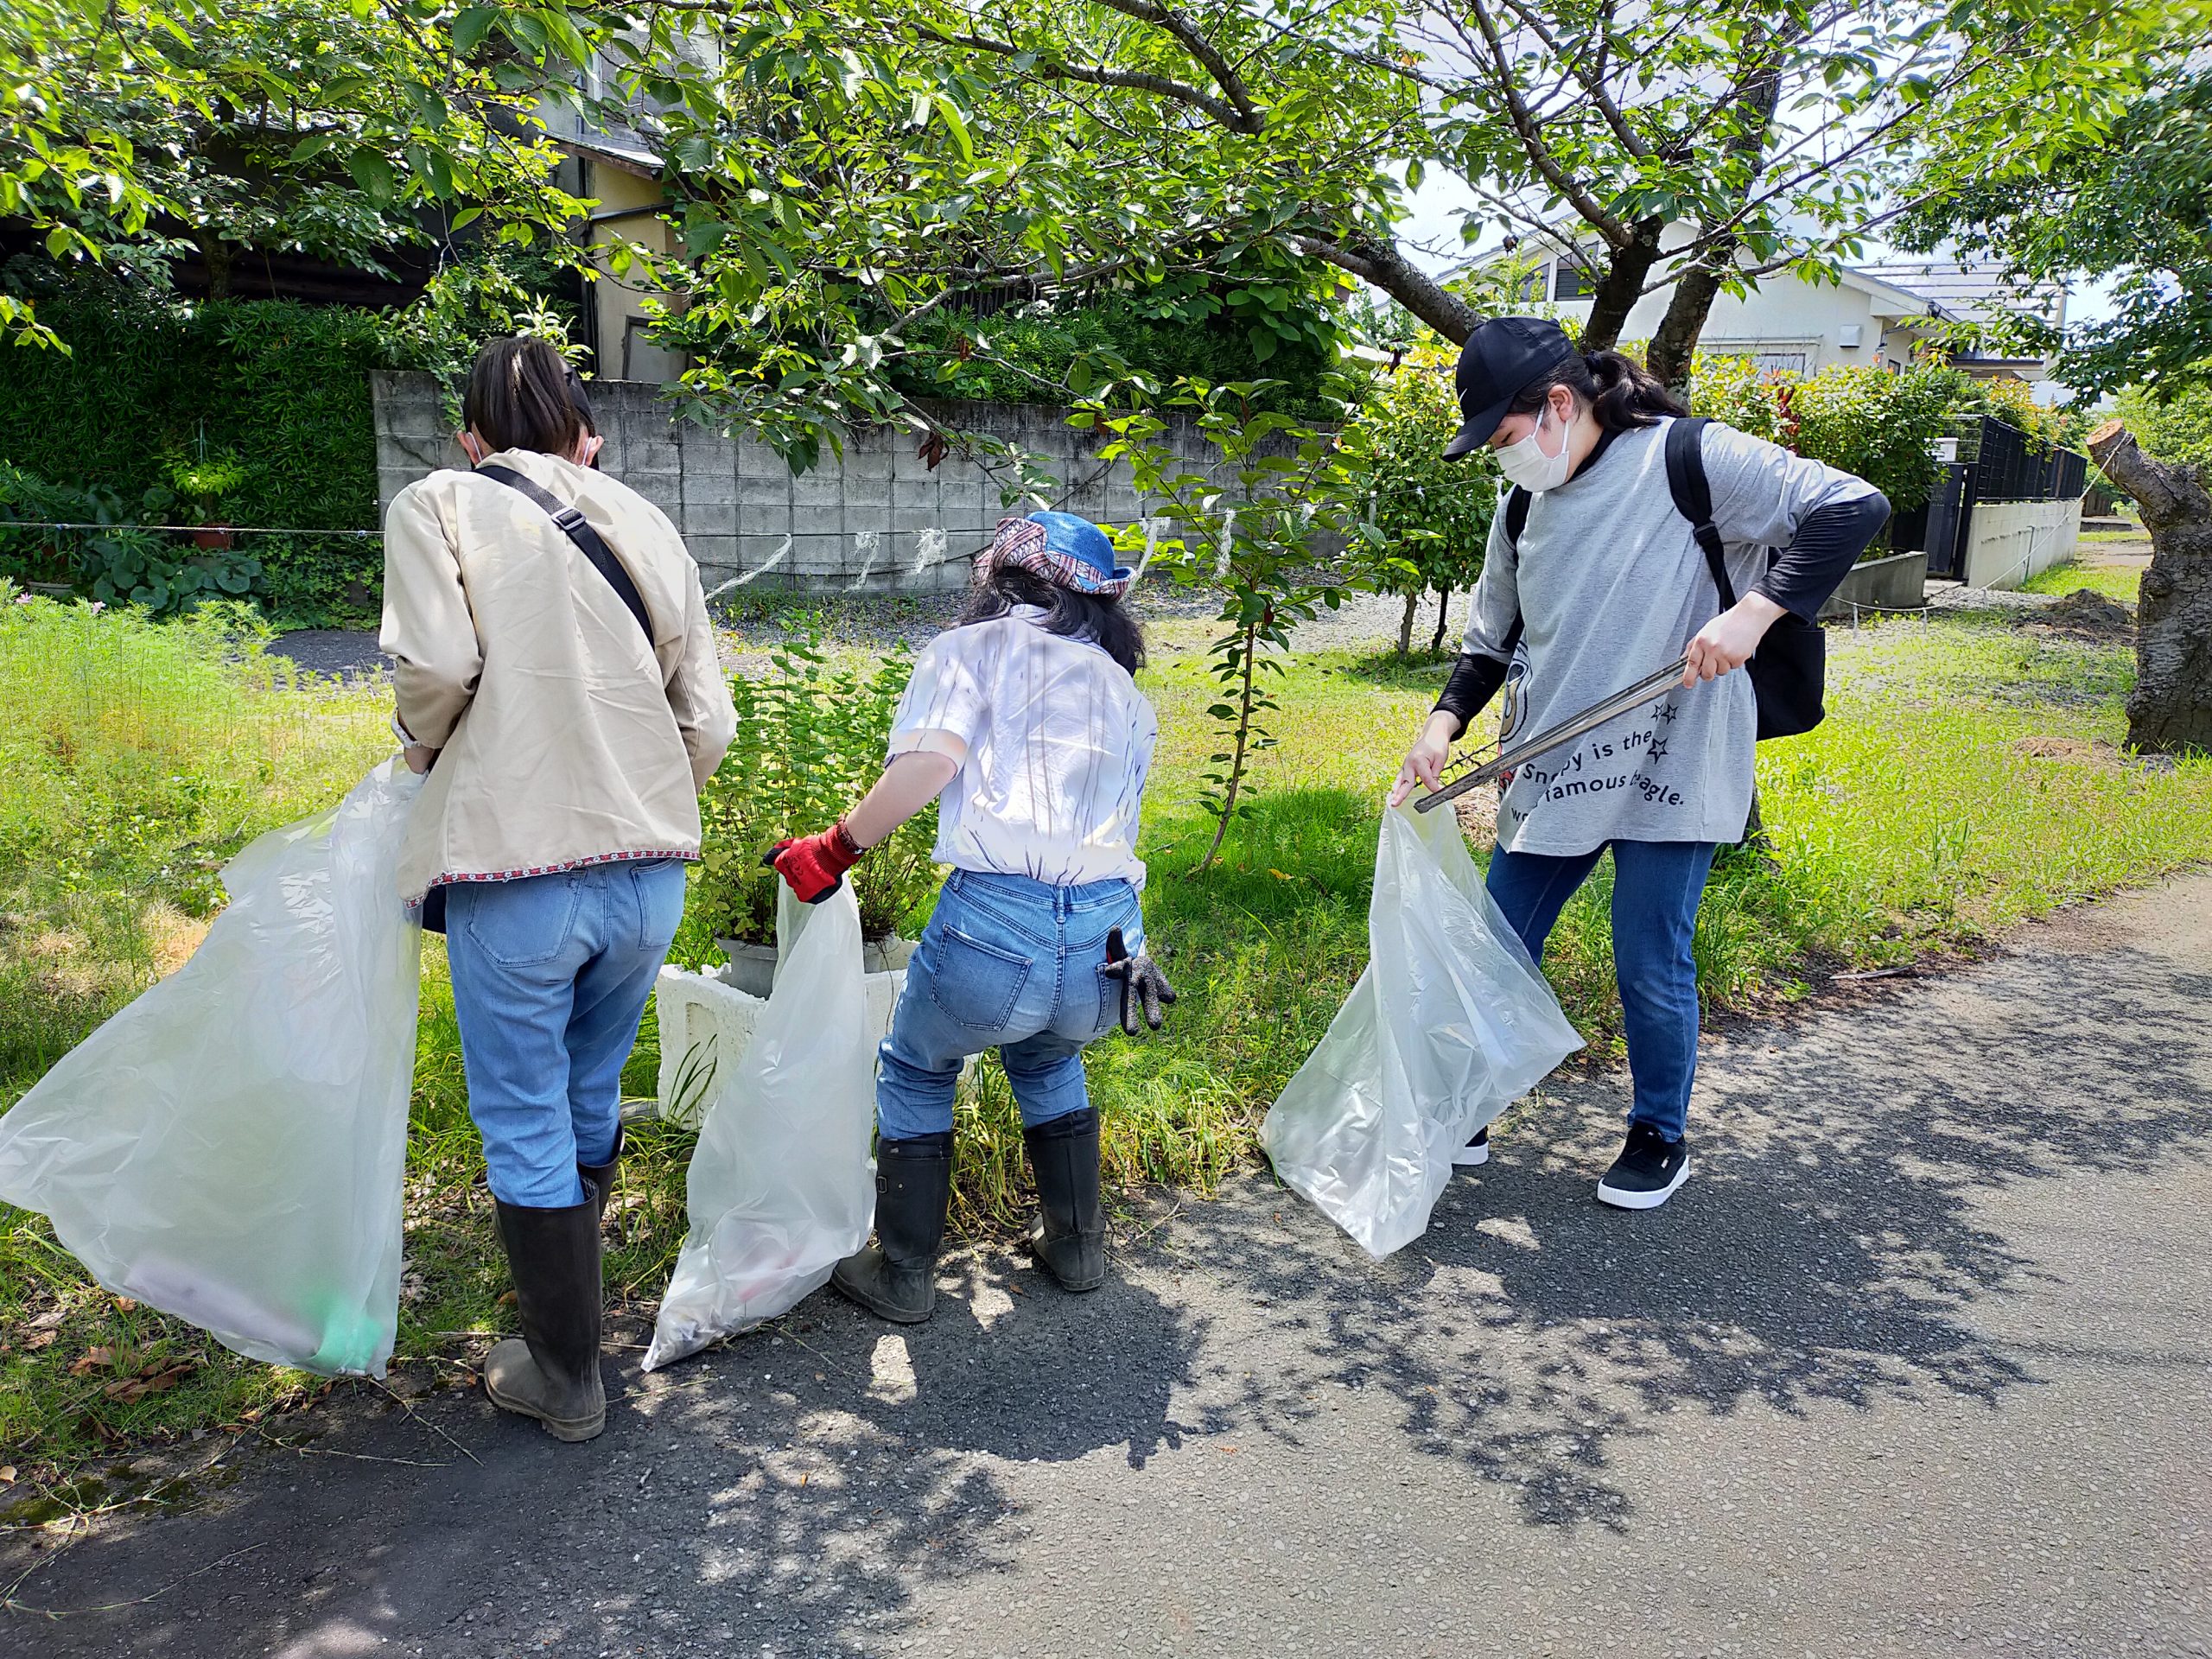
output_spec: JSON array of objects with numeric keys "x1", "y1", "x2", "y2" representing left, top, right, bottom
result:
[{"x1": 686, "y1": 624, "x2": 938, "y2": 944}]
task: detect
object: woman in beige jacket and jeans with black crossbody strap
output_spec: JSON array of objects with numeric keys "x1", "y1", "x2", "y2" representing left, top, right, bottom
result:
[{"x1": 383, "y1": 339, "x2": 736, "y2": 1440}]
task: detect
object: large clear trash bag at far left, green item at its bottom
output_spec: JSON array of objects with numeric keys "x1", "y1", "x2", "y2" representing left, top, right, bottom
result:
[{"x1": 0, "y1": 759, "x2": 423, "y2": 1376}]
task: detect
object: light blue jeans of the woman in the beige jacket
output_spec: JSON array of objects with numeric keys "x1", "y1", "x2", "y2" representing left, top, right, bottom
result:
[{"x1": 445, "y1": 858, "x2": 683, "y2": 1210}]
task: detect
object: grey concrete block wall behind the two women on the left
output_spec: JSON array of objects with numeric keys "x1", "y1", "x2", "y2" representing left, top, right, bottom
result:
[{"x1": 372, "y1": 372, "x2": 1210, "y2": 593}]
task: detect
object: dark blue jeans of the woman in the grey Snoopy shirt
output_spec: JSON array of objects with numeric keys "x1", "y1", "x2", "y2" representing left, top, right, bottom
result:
[{"x1": 1486, "y1": 841, "x2": 1714, "y2": 1141}]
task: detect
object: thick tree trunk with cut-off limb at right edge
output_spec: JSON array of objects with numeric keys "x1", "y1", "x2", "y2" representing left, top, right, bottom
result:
[{"x1": 2088, "y1": 420, "x2": 2212, "y2": 754}]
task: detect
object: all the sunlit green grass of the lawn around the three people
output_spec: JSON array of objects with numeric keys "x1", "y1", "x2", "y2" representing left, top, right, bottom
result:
[{"x1": 0, "y1": 606, "x2": 2212, "y2": 1520}]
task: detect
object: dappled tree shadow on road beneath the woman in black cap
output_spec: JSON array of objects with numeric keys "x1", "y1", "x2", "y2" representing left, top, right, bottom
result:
[{"x1": 1159, "y1": 925, "x2": 2212, "y2": 1531}]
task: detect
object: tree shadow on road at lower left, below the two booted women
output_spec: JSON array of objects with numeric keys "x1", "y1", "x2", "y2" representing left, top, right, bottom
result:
[{"x1": 0, "y1": 1261, "x2": 1199, "y2": 1659}]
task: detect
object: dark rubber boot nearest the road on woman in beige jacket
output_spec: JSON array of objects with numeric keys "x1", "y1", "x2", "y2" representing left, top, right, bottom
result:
[{"x1": 485, "y1": 1185, "x2": 606, "y2": 1440}]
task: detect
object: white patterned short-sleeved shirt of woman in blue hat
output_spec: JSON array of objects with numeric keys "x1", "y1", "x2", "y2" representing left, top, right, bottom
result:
[{"x1": 889, "y1": 606, "x2": 1159, "y2": 887}]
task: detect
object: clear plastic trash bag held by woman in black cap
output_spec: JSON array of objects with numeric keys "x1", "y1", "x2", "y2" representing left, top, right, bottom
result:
[{"x1": 1261, "y1": 807, "x2": 1581, "y2": 1259}]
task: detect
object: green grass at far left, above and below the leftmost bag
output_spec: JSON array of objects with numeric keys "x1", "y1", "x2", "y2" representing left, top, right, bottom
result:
[{"x1": 0, "y1": 584, "x2": 391, "y2": 1510}]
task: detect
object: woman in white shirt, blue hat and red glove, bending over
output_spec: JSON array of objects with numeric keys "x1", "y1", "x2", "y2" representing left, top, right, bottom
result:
[{"x1": 770, "y1": 513, "x2": 1174, "y2": 1325}]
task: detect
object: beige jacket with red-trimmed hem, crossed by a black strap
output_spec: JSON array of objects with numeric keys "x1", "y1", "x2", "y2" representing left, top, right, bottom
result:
[{"x1": 383, "y1": 449, "x2": 736, "y2": 902}]
